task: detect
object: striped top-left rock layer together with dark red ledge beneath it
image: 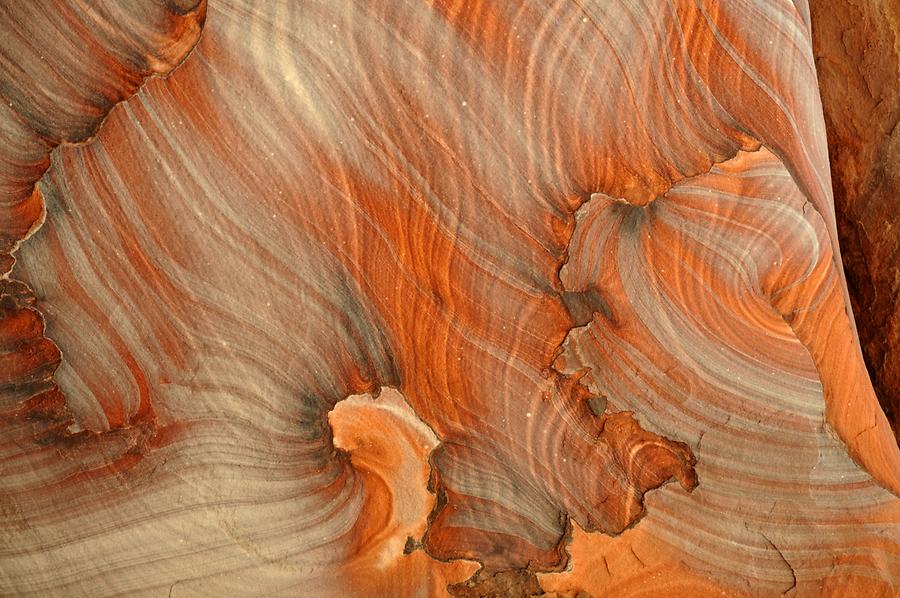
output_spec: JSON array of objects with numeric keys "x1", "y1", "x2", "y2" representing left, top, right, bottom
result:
[{"x1": 0, "y1": 0, "x2": 206, "y2": 460}]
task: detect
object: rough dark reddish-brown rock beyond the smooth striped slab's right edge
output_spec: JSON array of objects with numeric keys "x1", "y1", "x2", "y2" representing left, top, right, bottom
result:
[{"x1": 811, "y1": 1, "x2": 900, "y2": 446}]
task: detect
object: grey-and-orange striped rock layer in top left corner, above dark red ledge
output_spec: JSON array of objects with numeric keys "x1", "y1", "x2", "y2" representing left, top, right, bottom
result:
[{"x1": 0, "y1": 0, "x2": 206, "y2": 258}]
